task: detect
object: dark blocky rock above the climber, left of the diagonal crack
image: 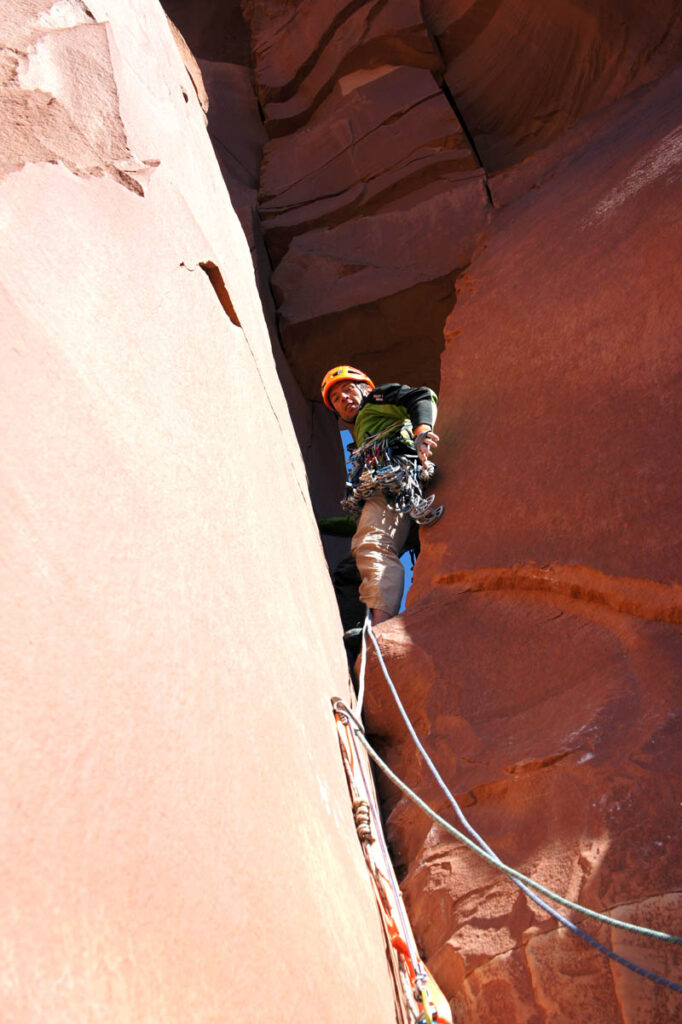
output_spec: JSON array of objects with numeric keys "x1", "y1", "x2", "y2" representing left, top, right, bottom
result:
[{"x1": 244, "y1": 0, "x2": 489, "y2": 396}]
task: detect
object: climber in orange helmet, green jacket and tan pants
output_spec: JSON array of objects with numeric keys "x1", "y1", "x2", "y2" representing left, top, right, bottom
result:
[{"x1": 322, "y1": 366, "x2": 442, "y2": 625}]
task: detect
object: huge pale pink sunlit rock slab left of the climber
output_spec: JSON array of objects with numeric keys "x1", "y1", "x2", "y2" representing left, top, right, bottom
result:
[{"x1": 0, "y1": 0, "x2": 395, "y2": 1024}]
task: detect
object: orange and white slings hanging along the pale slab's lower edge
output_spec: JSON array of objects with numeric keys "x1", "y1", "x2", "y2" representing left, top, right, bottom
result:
[{"x1": 332, "y1": 697, "x2": 452, "y2": 1024}]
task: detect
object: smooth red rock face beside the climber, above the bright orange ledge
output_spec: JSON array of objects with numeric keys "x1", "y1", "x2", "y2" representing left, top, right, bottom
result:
[{"x1": 409, "y1": 64, "x2": 682, "y2": 593}]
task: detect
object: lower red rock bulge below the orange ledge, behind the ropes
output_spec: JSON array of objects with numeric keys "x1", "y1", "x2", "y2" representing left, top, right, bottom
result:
[{"x1": 368, "y1": 590, "x2": 682, "y2": 1024}]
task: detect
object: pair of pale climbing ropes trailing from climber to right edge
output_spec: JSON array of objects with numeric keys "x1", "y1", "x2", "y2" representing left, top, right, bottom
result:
[{"x1": 339, "y1": 612, "x2": 682, "y2": 992}]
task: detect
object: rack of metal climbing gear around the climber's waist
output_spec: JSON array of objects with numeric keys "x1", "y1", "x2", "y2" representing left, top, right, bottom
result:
[{"x1": 341, "y1": 423, "x2": 443, "y2": 526}]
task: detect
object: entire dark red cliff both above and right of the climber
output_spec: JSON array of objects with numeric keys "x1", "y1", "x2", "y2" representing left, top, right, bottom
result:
[{"x1": 165, "y1": 8, "x2": 682, "y2": 1024}]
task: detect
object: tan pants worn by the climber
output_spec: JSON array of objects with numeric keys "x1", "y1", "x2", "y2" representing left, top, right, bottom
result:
[{"x1": 350, "y1": 495, "x2": 411, "y2": 615}]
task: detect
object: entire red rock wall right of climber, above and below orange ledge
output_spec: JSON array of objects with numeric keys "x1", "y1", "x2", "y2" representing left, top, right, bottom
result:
[{"x1": 367, "y1": 72, "x2": 682, "y2": 1024}]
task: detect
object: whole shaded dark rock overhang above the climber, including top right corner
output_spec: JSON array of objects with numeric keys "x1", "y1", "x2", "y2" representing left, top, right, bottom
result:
[{"x1": 231, "y1": 0, "x2": 682, "y2": 397}]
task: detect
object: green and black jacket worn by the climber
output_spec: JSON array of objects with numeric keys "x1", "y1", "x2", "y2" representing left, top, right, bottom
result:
[{"x1": 353, "y1": 384, "x2": 438, "y2": 446}]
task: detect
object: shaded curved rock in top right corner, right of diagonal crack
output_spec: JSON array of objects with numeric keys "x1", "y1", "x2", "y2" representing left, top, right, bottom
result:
[{"x1": 422, "y1": 0, "x2": 682, "y2": 173}]
